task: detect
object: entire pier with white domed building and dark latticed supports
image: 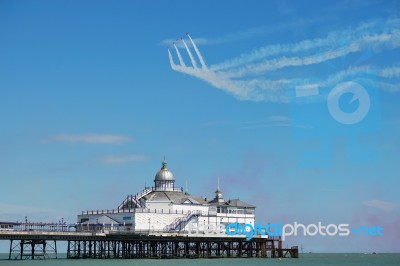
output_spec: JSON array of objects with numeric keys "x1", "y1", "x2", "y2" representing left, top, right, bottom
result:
[{"x1": 0, "y1": 158, "x2": 298, "y2": 260}]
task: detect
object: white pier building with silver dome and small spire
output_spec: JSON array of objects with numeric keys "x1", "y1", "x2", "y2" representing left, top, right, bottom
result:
[{"x1": 77, "y1": 160, "x2": 256, "y2": 232}]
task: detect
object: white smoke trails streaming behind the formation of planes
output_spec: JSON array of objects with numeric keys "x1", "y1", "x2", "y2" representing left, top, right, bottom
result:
[{"x1": 168, "y1": 18, "x2": 400, "y2": 103}]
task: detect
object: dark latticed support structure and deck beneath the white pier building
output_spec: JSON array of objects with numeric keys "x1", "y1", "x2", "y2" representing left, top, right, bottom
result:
[{"x1": 0, "y1": 231, "x2": 298, "y2": 260}]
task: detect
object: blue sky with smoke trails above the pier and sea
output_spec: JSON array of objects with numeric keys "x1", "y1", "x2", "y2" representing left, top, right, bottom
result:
[{"x1": 0, "y1": 1, "x2": 400, "y2": 252}]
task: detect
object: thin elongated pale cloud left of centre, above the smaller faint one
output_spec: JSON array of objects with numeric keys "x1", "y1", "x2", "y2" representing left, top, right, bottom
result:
[{"x1": 43, "y1": 133, "x2": 133, "y2": 144}]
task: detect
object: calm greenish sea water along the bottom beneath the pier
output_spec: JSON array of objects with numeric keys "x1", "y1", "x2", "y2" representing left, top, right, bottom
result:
[{"x1": 0, "y1": 253, "x2": 400, "y2": 266}]
